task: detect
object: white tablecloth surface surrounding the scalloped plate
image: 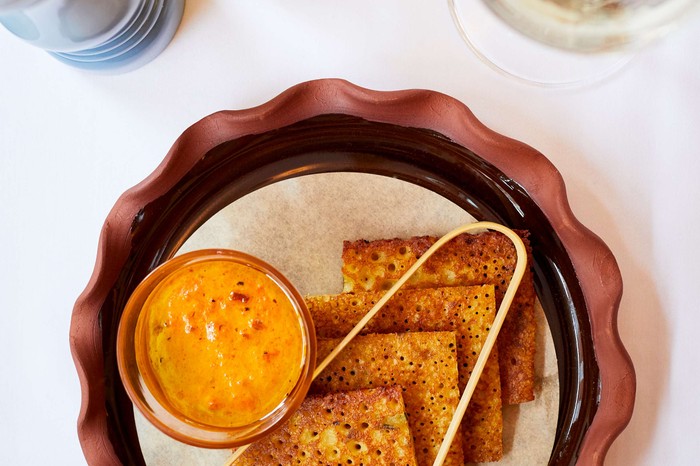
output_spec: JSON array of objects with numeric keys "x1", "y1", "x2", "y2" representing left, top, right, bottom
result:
[{"x1": 0, "y1": 0, "x2": 700, "y2": 465}]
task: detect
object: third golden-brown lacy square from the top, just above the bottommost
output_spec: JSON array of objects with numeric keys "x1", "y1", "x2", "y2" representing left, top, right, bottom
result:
[{"x1": 311, "y1": 332, "x2": 464, "y2": 466}]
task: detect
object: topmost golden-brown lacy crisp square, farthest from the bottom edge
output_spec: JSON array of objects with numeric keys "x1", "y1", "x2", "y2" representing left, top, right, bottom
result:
[{"x1": 343, "y1": 231, "x2": 536, "y2": 404}]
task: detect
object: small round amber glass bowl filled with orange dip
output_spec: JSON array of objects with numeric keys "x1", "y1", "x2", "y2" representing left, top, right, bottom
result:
[{"x1": 117, "y1": 249, "x2": 316, "y2": 448}]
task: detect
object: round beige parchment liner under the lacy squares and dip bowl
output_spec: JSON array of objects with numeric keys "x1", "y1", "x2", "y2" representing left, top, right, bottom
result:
[{"x1": 135, "y1": 173, "x2": 559, "y2": 466}]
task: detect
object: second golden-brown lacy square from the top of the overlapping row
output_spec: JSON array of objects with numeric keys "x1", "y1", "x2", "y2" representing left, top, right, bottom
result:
[{"x1": 306, "y1": 285, "x2": 503, "y2": 463}]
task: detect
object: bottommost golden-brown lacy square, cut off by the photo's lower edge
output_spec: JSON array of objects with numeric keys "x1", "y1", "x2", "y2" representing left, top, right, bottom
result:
[{"x1": 234, "y1": 386, "x2": 417, "y2": 466}]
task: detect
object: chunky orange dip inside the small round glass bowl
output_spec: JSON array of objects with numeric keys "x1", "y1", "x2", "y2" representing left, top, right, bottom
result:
[{"x1": 136, "y1": 260, "x2": 305, "y2": 427}]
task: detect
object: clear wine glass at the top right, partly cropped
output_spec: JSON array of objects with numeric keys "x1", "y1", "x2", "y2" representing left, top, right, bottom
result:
[{"x1": 448, "y1": 0, "x2": 700, "y2": 87}]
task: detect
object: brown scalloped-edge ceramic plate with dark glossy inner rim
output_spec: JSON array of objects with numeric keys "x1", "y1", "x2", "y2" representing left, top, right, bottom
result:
[{"x1": 70, "y1": 80, "x2": 636, "y2": 465}]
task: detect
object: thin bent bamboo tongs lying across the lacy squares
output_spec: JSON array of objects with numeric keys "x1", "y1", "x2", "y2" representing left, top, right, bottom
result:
[{"x1": 225, "y1": 222, "x2": 527, "y2": 466}]
